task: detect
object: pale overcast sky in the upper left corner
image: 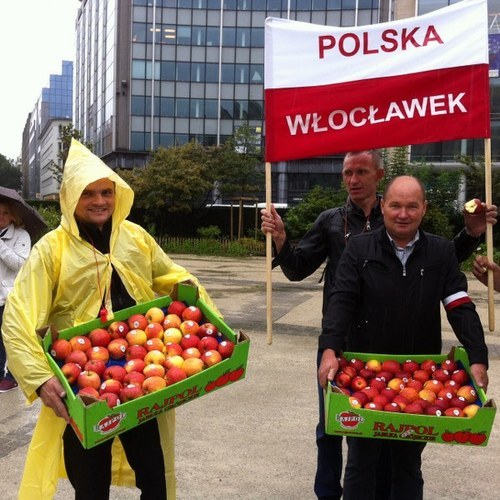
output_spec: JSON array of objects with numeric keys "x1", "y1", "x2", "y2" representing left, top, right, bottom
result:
[{"x1": 0, "y1": 0, "x2": 80, "y2": 159}]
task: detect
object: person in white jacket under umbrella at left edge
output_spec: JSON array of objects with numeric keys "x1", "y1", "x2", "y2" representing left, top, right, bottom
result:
[{"x1": 0, "y1": 198, "x2": 31, "y2": 393}]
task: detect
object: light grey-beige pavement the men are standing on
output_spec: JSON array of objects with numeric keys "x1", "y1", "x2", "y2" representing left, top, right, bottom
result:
[{"x1": 0, "y1": 255, "x2": 500, "y2": 500}]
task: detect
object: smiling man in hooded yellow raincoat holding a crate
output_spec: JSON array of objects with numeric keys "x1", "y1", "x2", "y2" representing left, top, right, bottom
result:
[{"x1": 3, "y1": 140, "x2": 216, "y2": 500}]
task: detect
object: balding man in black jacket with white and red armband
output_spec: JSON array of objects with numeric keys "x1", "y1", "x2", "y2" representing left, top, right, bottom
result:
[{"x1": 318, "y1": 176, "x2": 488, "y2": 500}]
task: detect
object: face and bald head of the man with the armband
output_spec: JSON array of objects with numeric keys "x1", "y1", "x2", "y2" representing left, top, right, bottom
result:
[{"x1": 381, "y1": 177, "x2": 427, "y2": 246}]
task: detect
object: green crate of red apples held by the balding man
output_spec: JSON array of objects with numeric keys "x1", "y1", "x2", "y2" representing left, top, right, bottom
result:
[{"x1": 326, "y1": 347, "x2": 495, "y2": 445}]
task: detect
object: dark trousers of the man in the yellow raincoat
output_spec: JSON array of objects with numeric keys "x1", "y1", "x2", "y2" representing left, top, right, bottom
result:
[{"x1": 63, "y1": 419, "x2": 167, "y2": 500}]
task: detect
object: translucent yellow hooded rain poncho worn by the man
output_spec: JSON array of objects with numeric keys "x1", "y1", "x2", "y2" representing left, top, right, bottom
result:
[{"x1": 2, "y1": 140, "x2": 217, "y2": 500}]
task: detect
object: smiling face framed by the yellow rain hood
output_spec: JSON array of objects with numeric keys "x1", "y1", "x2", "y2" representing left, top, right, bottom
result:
[{"x1": 75, "y1": 179, "x2": 115, "y2": 229}]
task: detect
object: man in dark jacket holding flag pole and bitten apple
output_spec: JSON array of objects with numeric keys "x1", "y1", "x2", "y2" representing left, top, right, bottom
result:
[{"x1": 261, "y1": 150, "x2": 497, "y2": 500}]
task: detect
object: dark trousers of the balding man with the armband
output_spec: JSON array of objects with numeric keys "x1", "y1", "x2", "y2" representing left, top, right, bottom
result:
[{"x1": 343, "y1": 438, "x2": 425, "y2": 500}]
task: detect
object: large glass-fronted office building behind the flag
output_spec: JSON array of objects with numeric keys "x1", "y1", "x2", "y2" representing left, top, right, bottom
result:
[{"x1": 74, "y1": 0, "x2": 500, "y2": 204}]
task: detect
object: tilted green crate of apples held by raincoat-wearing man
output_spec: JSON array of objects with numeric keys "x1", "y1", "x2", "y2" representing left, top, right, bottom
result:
[{"x1": 43, "y1": 285, "x2": 249, "y2": 447}]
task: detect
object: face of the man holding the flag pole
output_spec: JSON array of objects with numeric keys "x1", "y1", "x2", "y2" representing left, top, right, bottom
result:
[{"x1": 342, "y1": 152, "x2": 384, "y2": 205}]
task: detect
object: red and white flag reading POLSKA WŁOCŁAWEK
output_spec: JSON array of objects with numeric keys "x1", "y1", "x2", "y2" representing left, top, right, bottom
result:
[{"x1": 264, "y1": 0, "x2": 490, "y2": 162}]
